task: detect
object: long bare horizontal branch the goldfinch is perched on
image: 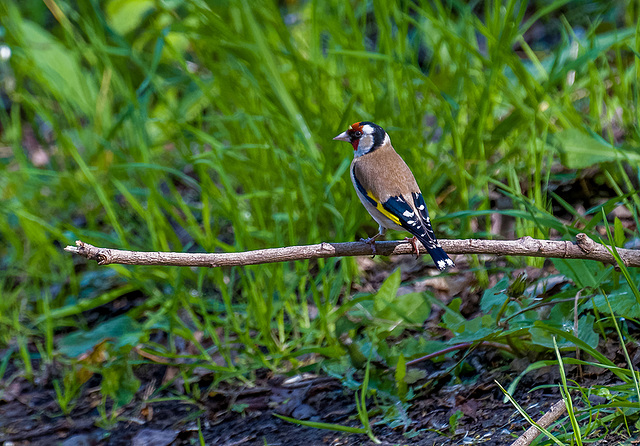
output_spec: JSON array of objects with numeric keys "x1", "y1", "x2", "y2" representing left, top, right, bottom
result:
[{"x1": 65, "y1": 234, "x2": 640, "y2": 268}]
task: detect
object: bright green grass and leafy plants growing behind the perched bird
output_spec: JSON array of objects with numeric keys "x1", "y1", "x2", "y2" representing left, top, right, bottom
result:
[{"x1": 0, "y1": 0, "x2": 640, "y2": 435}]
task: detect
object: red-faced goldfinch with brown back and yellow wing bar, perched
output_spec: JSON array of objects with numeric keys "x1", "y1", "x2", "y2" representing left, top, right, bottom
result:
[{"x1": 333, "y1": 121, "x2": 455, "y2": 271}]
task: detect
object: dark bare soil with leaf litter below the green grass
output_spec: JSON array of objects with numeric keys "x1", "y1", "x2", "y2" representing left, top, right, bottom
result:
[{"x1": 0, "y1": 344, "x2": 640, "y2": 446}]
